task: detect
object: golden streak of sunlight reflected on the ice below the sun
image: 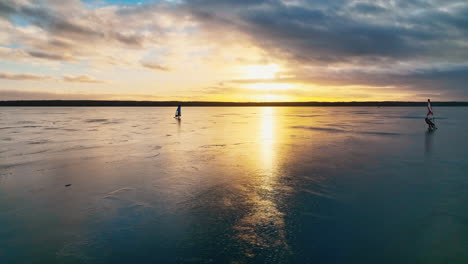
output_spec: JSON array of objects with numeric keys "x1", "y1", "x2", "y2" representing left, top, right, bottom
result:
[{"x1": 234, "y1": 107, "x2": 289, "y2": 258}]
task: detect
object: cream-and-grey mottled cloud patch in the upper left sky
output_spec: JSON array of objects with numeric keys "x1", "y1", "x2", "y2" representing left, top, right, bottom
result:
[{"x1": 0, "y1": 0, "x2": 164, "y2": 62}]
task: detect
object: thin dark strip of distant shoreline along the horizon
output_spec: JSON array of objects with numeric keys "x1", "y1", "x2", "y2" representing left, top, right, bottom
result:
[{"x1": 0, "y1": 100, "x2": 468, "y2": 107}]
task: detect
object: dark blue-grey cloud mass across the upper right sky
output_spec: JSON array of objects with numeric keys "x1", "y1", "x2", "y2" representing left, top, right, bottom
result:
[{"x1": 189, "y1": 1, "x2": 468, "y2": 63}]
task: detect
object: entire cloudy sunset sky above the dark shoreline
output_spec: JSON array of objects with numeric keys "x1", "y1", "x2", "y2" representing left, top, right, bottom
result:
[{"x1": 0, "y1": 0, "x2": 468, "y2": 101}]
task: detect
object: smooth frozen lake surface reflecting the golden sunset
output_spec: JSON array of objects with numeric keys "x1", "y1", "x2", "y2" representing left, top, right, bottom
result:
[{"x1": 0, "y1": 107, "x2": 468, "y2": 263}]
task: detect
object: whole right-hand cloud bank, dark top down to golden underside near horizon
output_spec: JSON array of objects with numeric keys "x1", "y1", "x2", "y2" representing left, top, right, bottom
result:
[{"x1": 180, "y1": 0, "x2": 468, "y2": 98}]
